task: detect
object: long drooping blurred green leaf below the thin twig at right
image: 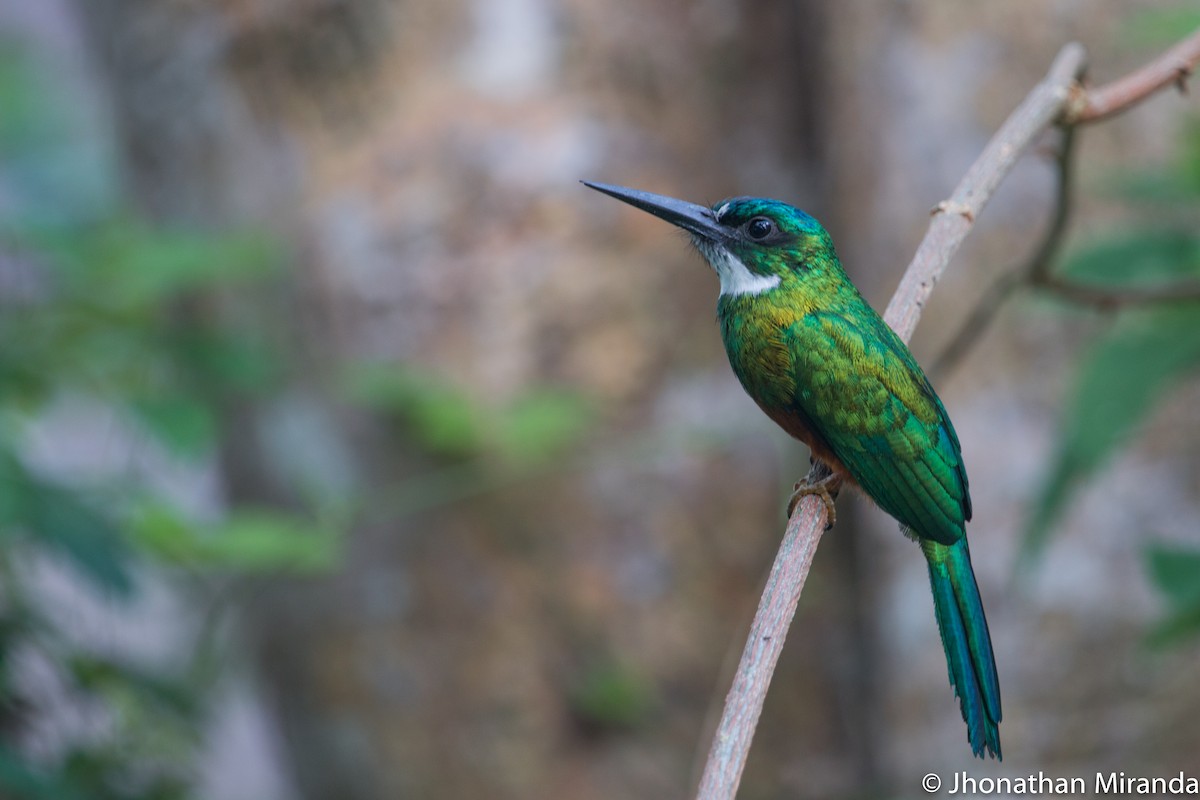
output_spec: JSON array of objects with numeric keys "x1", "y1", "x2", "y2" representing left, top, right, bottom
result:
[{"x1": 1022, "y1": 306, "x2": 1200, "y2": 559}]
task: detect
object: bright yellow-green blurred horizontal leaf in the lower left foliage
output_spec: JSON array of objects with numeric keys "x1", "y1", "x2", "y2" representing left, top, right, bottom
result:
[{"x1": 130, "y1": 504, "x2": 341, "y2": 572}]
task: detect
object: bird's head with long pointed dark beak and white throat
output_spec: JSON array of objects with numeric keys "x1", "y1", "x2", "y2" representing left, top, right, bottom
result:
[{"x1": 583, "y1": 181, "x2": 836, "y2": 296}]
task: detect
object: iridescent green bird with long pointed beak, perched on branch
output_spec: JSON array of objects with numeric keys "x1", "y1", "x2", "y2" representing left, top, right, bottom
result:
[{"x1": 581, "y1": 181, "x2": 1003, "y2": 760}]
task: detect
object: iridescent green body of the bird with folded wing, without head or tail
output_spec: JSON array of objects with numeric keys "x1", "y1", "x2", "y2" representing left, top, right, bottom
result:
[{"x1": 719, "y1": 276, "x2": 971, "y2": 545}]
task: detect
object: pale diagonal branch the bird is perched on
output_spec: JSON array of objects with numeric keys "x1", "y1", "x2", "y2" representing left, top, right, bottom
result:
[{"x1": 697, "y1": 43, "x2": 1086, "y2": 800}]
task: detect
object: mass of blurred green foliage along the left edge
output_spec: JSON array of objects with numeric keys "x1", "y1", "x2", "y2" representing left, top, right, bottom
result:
[{"x1": 0, "y1": 40, "x2": 344, "y2": 800}]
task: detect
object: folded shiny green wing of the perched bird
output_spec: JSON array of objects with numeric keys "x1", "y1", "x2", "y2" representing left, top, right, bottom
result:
[{"x1": 786, "y1": 303, "x2": 971, "y2": 545}]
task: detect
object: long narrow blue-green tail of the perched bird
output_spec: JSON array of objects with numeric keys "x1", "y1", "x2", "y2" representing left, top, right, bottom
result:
[{"x1": 920, "y1": 539, "x2": 1002, "y2": 759}]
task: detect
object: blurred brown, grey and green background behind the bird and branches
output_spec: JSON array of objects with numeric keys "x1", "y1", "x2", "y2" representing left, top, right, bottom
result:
[{"x1": 0, "y1": 0, "x2": 1200, "y2": 800}]
